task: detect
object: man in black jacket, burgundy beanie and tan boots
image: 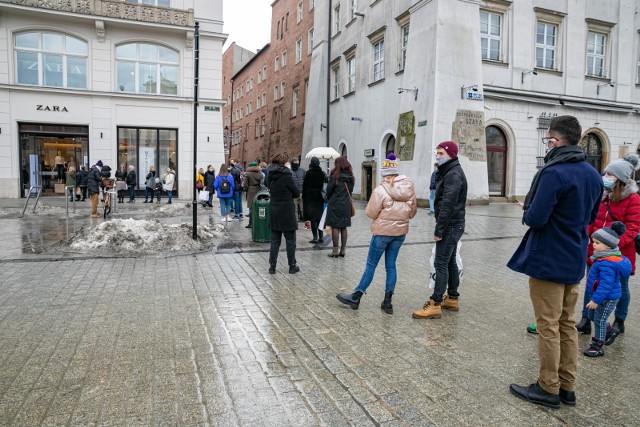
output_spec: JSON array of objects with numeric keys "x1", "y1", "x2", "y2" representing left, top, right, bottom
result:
[{"x1": 413, "y1": 141, "x2": 467, "y2": 319}]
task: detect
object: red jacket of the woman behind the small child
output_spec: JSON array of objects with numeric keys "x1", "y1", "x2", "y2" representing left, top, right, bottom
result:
[{"x1": 587, "y1": 179, "x2": 640, "y2": 274}]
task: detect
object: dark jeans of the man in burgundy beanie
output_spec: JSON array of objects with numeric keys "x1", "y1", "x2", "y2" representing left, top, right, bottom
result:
[{"x1": 431, "y1": 224, "x2": 464, "y2": 304}]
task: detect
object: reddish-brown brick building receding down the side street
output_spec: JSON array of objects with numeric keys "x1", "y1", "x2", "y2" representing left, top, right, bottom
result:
[{"x1": 223, "y1": 0, "x2": 314, "y2": 165}]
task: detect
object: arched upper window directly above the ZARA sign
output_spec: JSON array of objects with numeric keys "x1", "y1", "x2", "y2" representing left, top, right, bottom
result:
[{"x1": 15, "y1": 31, "x2": 89, "y2": 89}]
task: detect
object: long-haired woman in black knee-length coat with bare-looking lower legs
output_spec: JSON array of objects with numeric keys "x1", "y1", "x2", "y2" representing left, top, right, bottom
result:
[{"x1": 325, "y1": 157, "x2": 355, "y2": 258}]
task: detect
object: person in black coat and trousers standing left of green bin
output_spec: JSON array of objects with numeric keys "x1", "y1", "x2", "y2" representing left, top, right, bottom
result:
[{"x1": 267, "y1": 154, "x2": 300, "y2": 274}]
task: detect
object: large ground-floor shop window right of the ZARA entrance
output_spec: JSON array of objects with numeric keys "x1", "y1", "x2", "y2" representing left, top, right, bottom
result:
[{"x1": 118, "y1": 127, "x2": 179, "y2": 191}]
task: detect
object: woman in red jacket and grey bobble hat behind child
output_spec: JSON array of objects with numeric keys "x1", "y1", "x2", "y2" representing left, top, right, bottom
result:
[{"x1": 576, "y1": 155, "x2": 640, "y2": 345}]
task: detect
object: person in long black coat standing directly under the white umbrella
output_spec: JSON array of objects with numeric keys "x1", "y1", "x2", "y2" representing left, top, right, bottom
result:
[{"x1": 302, "y1": 157, "x2": 327, "y2": 243}]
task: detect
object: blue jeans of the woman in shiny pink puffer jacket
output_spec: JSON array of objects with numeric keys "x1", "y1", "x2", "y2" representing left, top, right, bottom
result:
[{"x1": 356, "y1": 236, "x2": 406, "y2": 293}]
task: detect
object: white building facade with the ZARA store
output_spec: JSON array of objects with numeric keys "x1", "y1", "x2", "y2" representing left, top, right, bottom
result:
[{"x1": 0, "y1": 0, "x2": 226, "y2": 198}]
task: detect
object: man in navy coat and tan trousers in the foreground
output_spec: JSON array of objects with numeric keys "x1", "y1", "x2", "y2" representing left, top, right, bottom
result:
[{"x1": 507, "y1": 116, "x2": 603, "y2": 409}]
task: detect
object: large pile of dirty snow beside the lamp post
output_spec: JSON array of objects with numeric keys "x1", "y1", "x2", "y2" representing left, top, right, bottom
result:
[{"x1": 56, "y1": 219, "x2": 224, "y2": 253}]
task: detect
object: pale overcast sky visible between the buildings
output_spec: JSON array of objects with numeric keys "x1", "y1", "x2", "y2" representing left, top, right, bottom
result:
[{"x1": 222, "y1": 0, "x2": 273, "y2": 52}]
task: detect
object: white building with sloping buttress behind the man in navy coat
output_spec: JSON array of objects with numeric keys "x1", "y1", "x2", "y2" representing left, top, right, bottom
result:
[{"x1": 303, "y1": 0, "x2": 640, "y2": 203}]
